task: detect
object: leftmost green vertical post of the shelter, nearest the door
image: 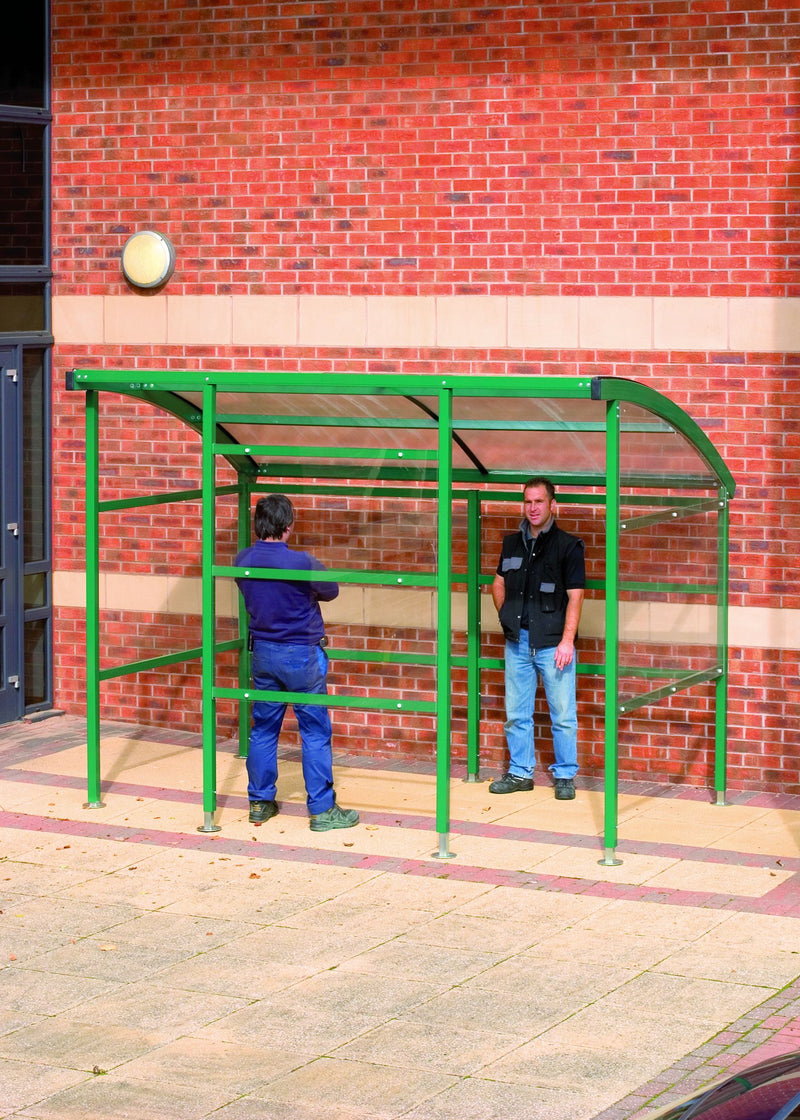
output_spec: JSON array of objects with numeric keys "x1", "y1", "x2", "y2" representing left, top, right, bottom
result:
[{"x1": 84, "y1": 389, "x2": 104, "y2": 809}]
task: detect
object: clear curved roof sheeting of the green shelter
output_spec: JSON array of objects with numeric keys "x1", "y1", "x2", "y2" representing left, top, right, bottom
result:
[{"x1": 175, "y1": 392, "x2": 717, "y2": 485}]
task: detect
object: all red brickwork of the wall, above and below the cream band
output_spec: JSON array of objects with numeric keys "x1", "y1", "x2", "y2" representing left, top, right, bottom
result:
[{"x1": 53, "y1": 0, "x2": 800, "y2": 792}]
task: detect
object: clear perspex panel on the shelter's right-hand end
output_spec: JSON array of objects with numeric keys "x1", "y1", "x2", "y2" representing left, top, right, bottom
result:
[{"x1": 618, "y1": 488, "x2": 719, "y2": 697}]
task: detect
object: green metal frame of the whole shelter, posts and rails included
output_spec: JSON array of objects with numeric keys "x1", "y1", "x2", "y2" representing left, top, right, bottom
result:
[{"x1": 67, "y1": 368, "x2": 735, "y2": 866}]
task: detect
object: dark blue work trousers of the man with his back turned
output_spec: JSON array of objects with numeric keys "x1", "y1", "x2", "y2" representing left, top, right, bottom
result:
[{"x1": 248, "y1": 640, "x2": 336, "y2": 815}]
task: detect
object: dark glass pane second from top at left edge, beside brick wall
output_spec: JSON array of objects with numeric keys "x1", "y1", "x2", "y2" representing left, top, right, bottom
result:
[{"x1": 0, "y1": 121, "x2": 45, "y2": 266}]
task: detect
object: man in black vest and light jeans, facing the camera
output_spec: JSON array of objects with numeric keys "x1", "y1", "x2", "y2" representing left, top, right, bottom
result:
[{"x1": 489, "y1": 478, "x2": 586, "y2": 801}]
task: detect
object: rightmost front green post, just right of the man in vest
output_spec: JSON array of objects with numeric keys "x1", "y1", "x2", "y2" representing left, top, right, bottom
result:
[{"x1": 599, "y1": 401, "x2": 622, "y2": 867}]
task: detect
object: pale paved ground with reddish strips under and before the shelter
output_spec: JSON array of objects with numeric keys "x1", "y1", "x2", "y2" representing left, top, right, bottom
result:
[{"x1": 0, "y1": 716, "x2": 800, "y2": 1120}]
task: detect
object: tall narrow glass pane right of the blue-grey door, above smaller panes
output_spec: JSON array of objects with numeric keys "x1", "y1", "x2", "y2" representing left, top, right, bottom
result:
[{"x1": 22, "y1": 349, "x2": 49, "y2": 563}]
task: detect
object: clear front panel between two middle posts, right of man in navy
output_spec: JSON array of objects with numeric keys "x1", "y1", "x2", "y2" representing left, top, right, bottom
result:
[{"x1": 224, "y1": 473, "x2": 437, "y2": 707}]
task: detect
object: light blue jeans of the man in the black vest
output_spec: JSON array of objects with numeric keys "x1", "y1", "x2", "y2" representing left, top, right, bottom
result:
[{"x1": 505, "y1": 629, "x2": 578, "y2": 777}]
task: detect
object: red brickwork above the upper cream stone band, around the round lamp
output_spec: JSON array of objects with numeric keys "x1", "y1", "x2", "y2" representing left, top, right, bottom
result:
[{"x1": 53, "y1": 0, "x2": 800, "y2": 296}]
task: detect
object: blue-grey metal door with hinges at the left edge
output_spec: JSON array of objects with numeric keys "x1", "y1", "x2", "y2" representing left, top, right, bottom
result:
[{"x1": 0, "y1": 348, "x2": 24, "y2": 724}]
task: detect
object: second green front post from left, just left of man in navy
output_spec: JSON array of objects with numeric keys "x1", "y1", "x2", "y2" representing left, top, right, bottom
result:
[{"x1": 197, "y1": 377, "x2": 220, "y2": 832}]
